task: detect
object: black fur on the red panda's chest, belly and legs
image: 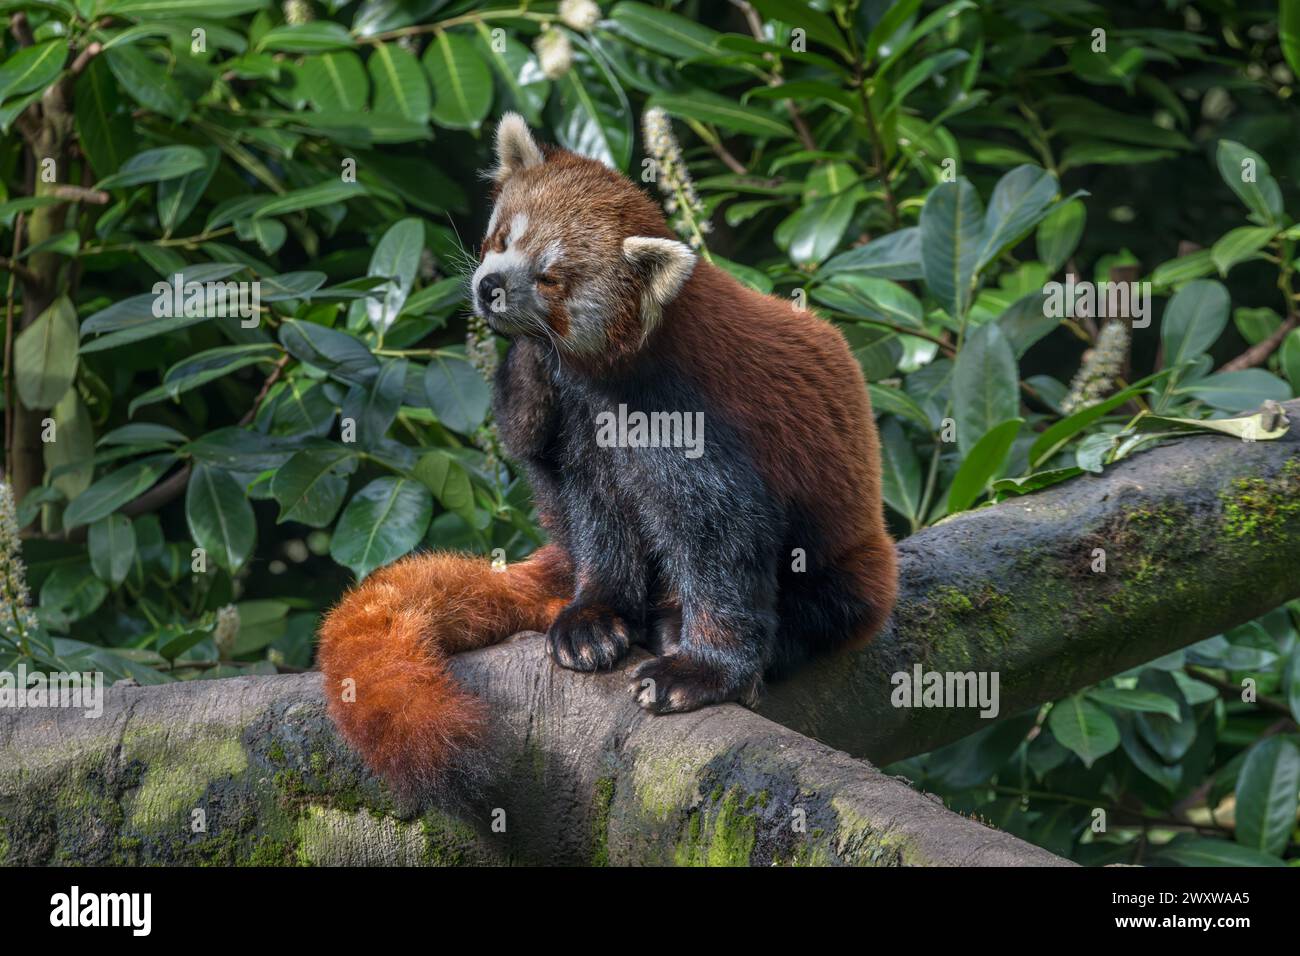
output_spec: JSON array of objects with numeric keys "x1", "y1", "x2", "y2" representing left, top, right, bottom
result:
[{"x1": 495, "y1": 342, "x2": 874, "y2": 710}]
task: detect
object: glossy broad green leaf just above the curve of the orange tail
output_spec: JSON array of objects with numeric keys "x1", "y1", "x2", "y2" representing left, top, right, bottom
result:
[{"x1": 329, "y1": 477, "x2": 433, "y2": 578}]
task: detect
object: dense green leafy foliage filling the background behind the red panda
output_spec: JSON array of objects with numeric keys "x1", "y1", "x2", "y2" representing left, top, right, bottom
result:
[{"x1": 0, "y1": 0, "x2": 1300, "y2": 864}]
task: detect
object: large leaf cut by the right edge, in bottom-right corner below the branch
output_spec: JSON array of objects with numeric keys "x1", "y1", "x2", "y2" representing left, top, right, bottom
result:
[{"x1": 1235, "y1": 736, "x2": 1300, "y2": 856}]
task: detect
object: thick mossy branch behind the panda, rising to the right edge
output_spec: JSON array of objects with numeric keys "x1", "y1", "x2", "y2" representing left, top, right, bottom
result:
[{"x1": 759, "y1": 401, "x2": 1300, "y2": 765}]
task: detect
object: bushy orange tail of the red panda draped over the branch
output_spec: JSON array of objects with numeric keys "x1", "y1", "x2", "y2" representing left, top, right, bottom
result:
[{"x1": 319, "y1": 545, "x2": 572, "y2": 792}]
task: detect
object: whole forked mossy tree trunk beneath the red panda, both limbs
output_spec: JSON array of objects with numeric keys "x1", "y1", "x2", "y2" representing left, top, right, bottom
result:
[{"x1": 0, "y1": 402, "x2": 1300, "y2": 865}]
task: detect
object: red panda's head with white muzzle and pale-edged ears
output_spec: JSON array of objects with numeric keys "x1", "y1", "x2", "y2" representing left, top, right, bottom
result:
[{"x1": 471, "y1": 113, "x2": 696, "y2": 363}]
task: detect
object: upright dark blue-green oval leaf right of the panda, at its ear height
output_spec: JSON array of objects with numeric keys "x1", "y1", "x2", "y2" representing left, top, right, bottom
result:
[{"x1": 920, "y1": 178, "x2": 977, "y2": 323}]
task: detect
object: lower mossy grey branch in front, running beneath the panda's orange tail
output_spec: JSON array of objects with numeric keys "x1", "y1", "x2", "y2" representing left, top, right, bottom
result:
[{"x1": 0, "y1": 665, "x2": 1065, "y2": 866}]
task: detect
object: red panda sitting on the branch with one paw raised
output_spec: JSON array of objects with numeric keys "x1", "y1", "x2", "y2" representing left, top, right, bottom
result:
[{"x1": 319, "y1": 114, "x2": 897, "y2": 791}]
